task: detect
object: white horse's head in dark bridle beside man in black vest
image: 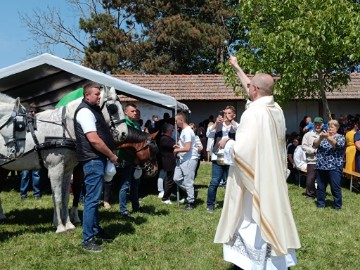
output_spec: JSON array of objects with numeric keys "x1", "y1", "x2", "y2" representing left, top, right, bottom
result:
[{"x1": 100, "y1": 87, "x2": 128, "y2": 144}]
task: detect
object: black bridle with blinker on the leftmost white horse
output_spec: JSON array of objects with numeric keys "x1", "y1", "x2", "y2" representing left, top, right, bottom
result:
[{"x1": 0, "y1": 104, "x2": 27, "y2": 160}]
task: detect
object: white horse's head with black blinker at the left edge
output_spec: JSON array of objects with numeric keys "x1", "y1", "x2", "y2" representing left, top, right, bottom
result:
[{"x1": 0, "y1": 94, "x2": 26, "y2": 160}]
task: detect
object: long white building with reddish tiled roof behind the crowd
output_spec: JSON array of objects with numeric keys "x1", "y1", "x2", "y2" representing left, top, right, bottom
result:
[{"x1": 114, "y1": 73, "x2": 360, "y2": 131}]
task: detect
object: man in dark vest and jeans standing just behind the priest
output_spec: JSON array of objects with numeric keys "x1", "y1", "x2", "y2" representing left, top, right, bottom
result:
[{"x1": 206, "y1": 106, "x2": 238, "y2": 213}]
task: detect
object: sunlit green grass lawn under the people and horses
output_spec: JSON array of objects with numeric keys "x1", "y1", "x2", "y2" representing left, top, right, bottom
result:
[{"x1": 0, "y1": 163, "x2": 360, "y2": 270}]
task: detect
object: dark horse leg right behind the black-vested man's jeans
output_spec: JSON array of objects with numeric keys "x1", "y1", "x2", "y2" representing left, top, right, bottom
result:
[{"x1": 70, "y1": 164, "x2": 84, "y2": 223}]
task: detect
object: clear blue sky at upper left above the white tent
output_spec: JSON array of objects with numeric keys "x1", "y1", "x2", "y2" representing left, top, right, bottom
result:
[{"x1": 0, "y1": 0, "x2": 74, "y2": 68}]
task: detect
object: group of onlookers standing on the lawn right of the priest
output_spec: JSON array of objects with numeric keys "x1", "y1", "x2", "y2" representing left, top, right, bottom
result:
[{"x1": 287, "y1": 114, "x2": 360, "y2": 210}]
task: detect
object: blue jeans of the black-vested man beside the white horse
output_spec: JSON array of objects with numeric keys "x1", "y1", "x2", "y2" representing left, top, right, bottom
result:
[{"x1": 82, "y1": 158, "x2": 106, "y2": 244}]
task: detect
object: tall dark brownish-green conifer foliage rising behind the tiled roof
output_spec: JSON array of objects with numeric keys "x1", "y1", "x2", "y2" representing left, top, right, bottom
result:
[{"x1": 80, "y1": 0, "x2": 237, "y2": 74}]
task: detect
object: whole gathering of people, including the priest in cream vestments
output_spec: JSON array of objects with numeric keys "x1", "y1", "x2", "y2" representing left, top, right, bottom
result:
[{"x1": 12, "y1": 56, "x2": 360, "y2": 269}]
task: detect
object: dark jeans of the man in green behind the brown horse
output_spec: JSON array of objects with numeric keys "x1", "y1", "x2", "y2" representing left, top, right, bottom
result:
[{"x1": 119, "y1": 165, "x2": 140, "y2": 213}]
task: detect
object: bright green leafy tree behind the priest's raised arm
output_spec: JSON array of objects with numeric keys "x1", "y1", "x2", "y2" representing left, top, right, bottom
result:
[{"x1": 224, "y1": 0, "x2": 360, "y2": 118}]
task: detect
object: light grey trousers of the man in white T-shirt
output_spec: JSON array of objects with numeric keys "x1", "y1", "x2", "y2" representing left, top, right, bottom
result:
[{"x1": 174, "y1": 159, "x2": 197, "y2": 204}]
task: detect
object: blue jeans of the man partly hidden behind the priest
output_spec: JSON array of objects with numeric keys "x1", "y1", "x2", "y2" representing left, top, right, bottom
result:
[{"x1": 206, "y1": 161, "x2": 230, "y2": 208}]
